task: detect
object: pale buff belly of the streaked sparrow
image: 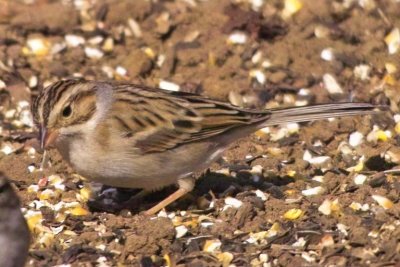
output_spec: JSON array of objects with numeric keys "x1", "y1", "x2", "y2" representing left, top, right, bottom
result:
[{"x1": 60, "y1": 140, "x2": 224, "y2": 190}]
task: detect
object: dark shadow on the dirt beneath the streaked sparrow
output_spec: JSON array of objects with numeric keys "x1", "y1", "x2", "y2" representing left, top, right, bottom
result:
[{"x1": 88, "y1": 170, "x2": 294, "y2": 213}]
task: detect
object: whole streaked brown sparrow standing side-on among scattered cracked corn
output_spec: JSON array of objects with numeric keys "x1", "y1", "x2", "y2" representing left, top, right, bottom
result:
[{"x1": 32, "y1": 80, "x2": 375, "y2": 214}]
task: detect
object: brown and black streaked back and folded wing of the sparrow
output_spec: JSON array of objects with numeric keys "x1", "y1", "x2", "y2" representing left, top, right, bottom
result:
[{"x1": 113, "y1": 87, "x2": 269, "y2": 153}]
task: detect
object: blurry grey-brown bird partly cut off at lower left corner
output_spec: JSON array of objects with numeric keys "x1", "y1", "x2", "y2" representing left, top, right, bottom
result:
[{"x1": 0, "y1": 174, "x2": 30, "y2": 267}]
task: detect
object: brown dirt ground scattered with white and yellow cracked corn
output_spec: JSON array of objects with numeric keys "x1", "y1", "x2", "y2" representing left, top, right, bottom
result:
[{"x1": 0, "y1": 0, "x2": 400, "y2": 267}]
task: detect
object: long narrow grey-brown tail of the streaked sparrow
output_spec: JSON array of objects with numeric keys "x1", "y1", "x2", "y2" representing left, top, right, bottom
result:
[{"x1": 262, "y1": 102, "x2": 386, "y2": 127}]
